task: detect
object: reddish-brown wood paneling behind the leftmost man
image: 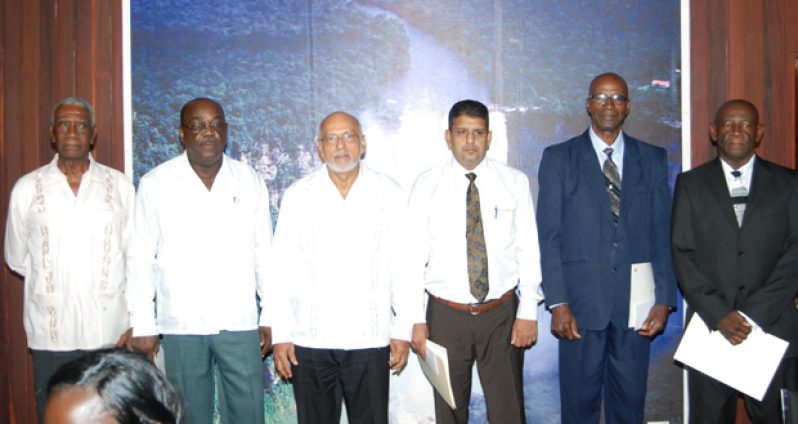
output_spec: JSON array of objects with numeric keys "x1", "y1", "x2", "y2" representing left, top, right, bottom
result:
[{"x1": 0, "y1": 0, "x2": 124, "y2": 424}]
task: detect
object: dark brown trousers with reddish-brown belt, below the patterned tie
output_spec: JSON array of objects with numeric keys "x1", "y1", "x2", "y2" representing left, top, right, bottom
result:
[{"x1": 427, "y1": 297, "x2": 526, "y2": 424}]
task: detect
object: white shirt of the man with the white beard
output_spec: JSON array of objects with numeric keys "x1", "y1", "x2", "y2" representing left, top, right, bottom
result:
[{"x1": 266, "y1": 163, "x2": 423, "y2": 349}]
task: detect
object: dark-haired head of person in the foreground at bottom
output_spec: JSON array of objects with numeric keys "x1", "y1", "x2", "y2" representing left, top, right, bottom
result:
[{"x1": 44, "y1": 350, "x2": 183, "y2": 424}]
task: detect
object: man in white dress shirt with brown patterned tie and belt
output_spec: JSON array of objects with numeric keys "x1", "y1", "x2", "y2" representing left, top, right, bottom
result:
[{"x1": 410, "y1": 100, "x2": 542, "y2": 423}]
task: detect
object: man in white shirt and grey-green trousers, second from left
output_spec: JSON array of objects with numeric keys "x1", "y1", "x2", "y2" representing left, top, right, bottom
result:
[{"x1": 127, "y1": 98, "x2": 272, "y2": 423}]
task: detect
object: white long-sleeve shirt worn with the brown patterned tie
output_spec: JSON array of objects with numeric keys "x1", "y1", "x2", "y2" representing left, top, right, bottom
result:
[{"x1": 410, "y1": 158, "x2": 543, "y2": 322}]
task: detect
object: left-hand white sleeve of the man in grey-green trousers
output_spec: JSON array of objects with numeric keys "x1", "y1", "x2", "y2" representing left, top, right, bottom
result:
[{"x1": 126, "y1": 178, "x2": 161, "y2": 337}]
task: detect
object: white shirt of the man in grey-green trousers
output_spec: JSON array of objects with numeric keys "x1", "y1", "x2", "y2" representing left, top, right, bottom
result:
[{"x1": 127, "y1": 153, "x2": 272, "y2": 336}]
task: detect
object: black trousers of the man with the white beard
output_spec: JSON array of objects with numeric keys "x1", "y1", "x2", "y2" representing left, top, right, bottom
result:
[{"x1": 291, "y1": 346, "x2": 390, "y2": 424}]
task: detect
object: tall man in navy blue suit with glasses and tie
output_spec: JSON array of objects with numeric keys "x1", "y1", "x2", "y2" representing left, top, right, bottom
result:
[{"x1": 537, "y1": 73, "x2": 676, "y2": 424}]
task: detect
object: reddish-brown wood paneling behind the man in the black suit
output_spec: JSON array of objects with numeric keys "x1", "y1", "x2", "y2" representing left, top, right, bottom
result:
[{"x1": 690, "y1": 0, "x2": 798, "y2": 168}]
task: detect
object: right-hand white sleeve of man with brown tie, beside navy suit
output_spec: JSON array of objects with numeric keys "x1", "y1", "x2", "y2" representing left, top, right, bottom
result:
[{"x1": 515, "y1": 174, "x2": 543, "y2": 320}]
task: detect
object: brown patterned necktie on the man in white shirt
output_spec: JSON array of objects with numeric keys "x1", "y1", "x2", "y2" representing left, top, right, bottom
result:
[{"x1": 466, "y1": 172, "x2": 489, "y2": 303}]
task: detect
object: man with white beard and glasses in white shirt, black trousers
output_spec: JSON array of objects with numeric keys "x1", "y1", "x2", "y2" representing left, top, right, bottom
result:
[{"x1": 265, "y1": 112, "x2": 423, "y2": 424}]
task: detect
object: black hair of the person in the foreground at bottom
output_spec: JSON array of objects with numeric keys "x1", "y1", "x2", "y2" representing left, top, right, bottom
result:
[{"x1": 47, "y1": 349, "x2": 185, "y2": 424}]
